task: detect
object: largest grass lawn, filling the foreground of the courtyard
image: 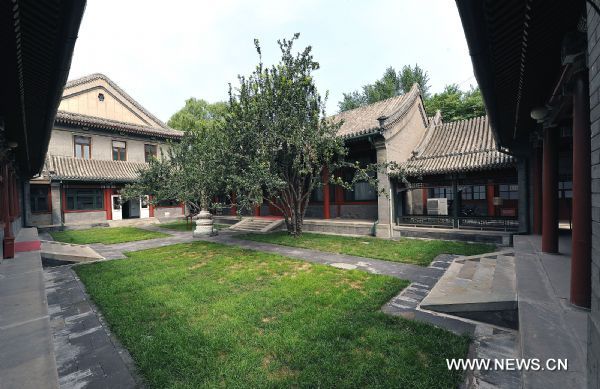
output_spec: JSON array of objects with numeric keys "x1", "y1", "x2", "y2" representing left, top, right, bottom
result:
[{"x1": 74, "y1": 242, "x2": 469, "y2": 388}]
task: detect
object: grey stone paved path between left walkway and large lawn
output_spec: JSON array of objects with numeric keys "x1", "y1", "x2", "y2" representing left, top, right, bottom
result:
[{"x1": 44, "y1": 266, "x2": 143, "y2": 389}]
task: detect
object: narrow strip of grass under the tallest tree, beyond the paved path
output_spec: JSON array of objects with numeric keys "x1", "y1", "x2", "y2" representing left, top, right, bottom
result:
[{"x1": 238, "y1": 231, "x2": 496, "y2": 266}]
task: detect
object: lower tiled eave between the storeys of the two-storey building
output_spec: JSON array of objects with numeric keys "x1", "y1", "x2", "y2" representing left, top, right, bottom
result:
[{"x1": 44, "y1": 155, "x2": 148, "y2": 182}]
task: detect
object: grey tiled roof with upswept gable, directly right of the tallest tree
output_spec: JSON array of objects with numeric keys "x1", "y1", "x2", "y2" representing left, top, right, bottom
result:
[{"x1": 329, "y1": 84, "x2": 420, "y2": 138}]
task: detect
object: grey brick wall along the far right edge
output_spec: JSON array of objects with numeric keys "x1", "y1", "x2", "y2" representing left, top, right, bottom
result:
[{"x1": 587, "y1": 5, "x2": 600, "y2": 389}]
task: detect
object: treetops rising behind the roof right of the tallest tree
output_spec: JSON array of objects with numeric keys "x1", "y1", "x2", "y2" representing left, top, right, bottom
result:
[{"x1": 338, "y1": 64, "x2": 429, "y2": 112}]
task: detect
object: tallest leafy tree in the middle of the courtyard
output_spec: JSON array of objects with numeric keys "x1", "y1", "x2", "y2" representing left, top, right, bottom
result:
[{"x1": 224, "y1": 34, "x2": 370, "y2": 236}]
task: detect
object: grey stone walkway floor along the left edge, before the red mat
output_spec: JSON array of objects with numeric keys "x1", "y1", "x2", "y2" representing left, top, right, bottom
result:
[{"x1": 0, "y1": 228, "x2": 58, "y2": 389}]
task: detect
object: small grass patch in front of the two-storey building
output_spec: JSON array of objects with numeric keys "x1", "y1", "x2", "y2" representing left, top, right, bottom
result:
[{"x1": 50, "y1": 227, "x2": 169, "y2": 244}]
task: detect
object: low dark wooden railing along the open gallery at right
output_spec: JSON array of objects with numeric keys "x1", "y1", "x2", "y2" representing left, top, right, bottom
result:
[{"x1": 397, "y1": 215, "x2": 519, "y2": 231}]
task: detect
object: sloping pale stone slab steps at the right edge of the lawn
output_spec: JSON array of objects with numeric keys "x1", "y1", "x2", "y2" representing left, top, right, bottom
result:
[{"x1": 420, "y1": 250, "x2": 518, "y2": 328}]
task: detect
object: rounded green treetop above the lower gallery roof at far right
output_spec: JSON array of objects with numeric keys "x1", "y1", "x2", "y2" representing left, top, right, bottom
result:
[{"x1": 425, "y1": 84, "x2": 485, "y2": 122}]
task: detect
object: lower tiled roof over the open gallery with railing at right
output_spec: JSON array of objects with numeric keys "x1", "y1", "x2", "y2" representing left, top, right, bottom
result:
[{"x1": 403, "y1": 116, "x2": 515, "y2": 175}]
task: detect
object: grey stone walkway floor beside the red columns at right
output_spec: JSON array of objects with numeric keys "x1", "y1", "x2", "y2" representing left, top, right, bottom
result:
[{"x1": 515, "y1": 234, "x2": 588, "y2": 388}]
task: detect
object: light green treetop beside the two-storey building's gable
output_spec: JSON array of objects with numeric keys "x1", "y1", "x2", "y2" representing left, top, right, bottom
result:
[{"x1": 167, "y1": 97, "x2": 227, "y2": 131}]
